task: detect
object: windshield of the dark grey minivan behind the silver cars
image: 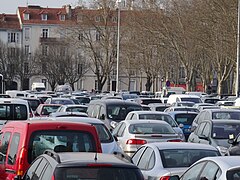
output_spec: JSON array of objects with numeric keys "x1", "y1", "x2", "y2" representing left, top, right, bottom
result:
[{"x1": 107, "y1": 105, "x2": 142, "y2": 122}]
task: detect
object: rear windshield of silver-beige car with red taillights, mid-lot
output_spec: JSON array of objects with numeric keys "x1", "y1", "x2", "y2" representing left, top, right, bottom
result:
[{"x1": 129, "y1": 123, "x2": 175, "y2": 134}]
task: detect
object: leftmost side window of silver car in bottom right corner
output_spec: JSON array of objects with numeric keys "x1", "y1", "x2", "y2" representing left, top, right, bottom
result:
[{"x1": 181, "y1": 162, "x2": 206, "y2": 180}]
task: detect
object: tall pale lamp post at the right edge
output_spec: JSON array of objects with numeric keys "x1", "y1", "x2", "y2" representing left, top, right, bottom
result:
[{"x1": 236, "y1": 0, "x2": 240, "y2": 97}]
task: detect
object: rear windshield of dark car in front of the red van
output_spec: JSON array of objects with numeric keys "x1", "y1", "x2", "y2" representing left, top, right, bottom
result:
[{"x1": 55, "y1": 167, "x2": 142, "y2": 180}]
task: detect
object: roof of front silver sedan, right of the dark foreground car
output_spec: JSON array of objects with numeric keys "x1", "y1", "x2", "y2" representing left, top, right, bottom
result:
[{"x1": 145, "y1": 142, "x2": 217, "y2": 151}]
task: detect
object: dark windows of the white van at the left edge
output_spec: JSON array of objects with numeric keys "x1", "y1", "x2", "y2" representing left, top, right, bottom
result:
[{"x1": 0, "y1": 104, "x2": 28, "y2": 120}]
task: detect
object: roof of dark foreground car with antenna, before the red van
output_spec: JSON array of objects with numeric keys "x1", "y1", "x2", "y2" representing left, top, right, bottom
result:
[{"x1": 47, "y1": 152, "x2": 137, "y2": 168}]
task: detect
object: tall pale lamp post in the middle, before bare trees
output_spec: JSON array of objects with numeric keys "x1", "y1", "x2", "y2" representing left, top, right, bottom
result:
[{"x1": 116, "y1": 0, "x2": 121, "y2": 92}]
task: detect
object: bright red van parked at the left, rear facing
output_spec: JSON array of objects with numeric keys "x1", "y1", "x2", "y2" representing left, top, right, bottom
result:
[{"x1": 0, "y1": 121, "x2": 102, "y2": 179}]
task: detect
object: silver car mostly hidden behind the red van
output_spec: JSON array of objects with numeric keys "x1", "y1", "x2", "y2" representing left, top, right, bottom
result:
[{"x1": 49, "y1": 117, "x2": 123, "y2": 154}]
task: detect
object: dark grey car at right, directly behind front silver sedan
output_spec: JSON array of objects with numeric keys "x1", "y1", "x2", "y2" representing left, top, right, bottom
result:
[{"x1": 188, "y1": 119, "x2": 240, "y2": 155}]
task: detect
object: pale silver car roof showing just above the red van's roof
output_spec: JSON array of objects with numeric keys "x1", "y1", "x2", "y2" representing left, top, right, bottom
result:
[{"x1": 49, "y1": 116, "x2": 104, "y2": 124}]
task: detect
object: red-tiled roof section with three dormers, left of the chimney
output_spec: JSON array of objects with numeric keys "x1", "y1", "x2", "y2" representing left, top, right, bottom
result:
[{"x1": 18, "y1": 6, "x2": 71, "y2": 25}]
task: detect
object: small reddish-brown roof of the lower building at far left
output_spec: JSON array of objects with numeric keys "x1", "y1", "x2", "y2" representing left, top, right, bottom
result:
[{"x1": 0, "y1": 14, "x2": 21, "y2": 31}]
